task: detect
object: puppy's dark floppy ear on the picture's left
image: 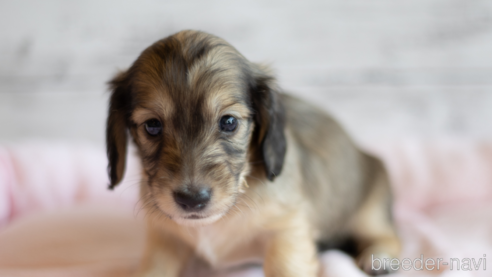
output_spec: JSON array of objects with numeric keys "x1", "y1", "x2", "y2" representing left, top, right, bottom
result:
[{"x1": 106, "y1": 72, "x2": 131, "y2": 189}]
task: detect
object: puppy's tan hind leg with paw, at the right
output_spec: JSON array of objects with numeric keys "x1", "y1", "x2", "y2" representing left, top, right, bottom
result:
[{"x1": 350, "y1": 159, "x2": 400, "y2": 275}]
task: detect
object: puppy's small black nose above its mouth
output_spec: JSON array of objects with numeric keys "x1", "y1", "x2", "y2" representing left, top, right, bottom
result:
[{"x1": 173, "y1": 188, "x2": 211, "y2": 212}]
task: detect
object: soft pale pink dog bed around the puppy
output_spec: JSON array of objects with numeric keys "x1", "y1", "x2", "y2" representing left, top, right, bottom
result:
[{"x1": 0, "y1": 140, "x2": 492, "y2": 277}]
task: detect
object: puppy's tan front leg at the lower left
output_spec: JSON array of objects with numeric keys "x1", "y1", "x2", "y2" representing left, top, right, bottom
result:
[{"x1": 136, "y1": 226, "x2": 192, "y2": 277}]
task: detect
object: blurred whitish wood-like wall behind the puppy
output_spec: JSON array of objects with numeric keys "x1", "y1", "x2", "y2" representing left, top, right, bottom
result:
[{"x1": 0, "y1": 0, "x2": 492, "y2": 147}]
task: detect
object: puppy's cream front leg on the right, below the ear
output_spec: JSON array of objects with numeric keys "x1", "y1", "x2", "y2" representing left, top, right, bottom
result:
[{"x1": 264, "y1": 213, "x2": 319, "y2": 277}]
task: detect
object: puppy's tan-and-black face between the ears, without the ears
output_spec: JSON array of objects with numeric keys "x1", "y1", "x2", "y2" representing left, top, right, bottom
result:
[{"x1": 130, "y1": 42, "x2": 254, "y2": 224}]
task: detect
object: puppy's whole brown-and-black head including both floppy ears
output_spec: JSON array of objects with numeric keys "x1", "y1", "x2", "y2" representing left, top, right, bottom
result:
[{"x1": 106, "y1": 31, "x2": 286, "y2": 225}]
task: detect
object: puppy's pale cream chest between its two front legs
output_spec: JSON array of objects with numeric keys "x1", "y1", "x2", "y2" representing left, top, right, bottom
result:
[{"x1": 183, "y1": 218, "x2": 264, "y2": 268}]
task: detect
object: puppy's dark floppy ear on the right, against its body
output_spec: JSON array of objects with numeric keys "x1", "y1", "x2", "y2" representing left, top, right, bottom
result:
[{"x1": 251, "y1": 69, "x2": 287, "y2": 181}]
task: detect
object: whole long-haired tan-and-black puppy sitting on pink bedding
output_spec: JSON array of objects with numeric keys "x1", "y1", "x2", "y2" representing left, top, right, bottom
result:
[{"x1": 106, "y1": 31, "x2": 400, "y2": 277}]
